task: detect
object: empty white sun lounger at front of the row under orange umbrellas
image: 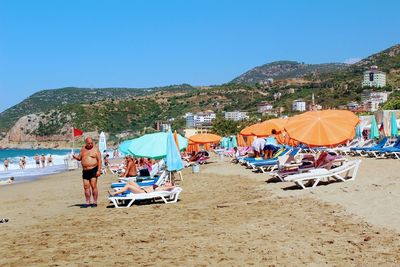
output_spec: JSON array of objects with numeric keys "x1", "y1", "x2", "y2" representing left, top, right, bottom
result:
[{"x1": 284, "y1": 160, "x2": 361, "y2": 189}]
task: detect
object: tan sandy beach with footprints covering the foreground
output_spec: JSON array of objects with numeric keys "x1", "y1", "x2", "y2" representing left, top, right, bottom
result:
[{"x1": 0, "y1": 156, "x2": 400, "y2": 266}]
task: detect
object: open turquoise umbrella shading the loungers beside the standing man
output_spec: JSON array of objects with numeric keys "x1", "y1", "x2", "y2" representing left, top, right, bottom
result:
[{"x1": 128, "y1": 132, "x2": 188, "y2": 159}]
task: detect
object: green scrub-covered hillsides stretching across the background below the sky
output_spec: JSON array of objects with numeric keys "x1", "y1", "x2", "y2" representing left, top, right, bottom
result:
[{"x1": 0, "y1": 45, "x2": 400, "y2": 142}]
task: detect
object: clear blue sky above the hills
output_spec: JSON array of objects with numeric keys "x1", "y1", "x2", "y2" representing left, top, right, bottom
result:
[{"x1": 0, "y1": 0, "x2": 400, "y2": 111}]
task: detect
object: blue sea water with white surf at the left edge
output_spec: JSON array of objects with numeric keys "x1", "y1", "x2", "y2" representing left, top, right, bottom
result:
[{"x1": 0, "y1": 149, "x2": 74, "y2": 182}]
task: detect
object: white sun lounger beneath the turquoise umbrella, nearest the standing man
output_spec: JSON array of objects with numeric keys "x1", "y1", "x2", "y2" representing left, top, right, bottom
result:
[{"x1": 108, "y1": 187, "x2": 182, "y2": 208}]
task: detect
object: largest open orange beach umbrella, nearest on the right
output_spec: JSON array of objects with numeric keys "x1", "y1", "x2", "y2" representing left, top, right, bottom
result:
[{"x1": 285, "y1": 110, "x2": 360, "y2": 149}]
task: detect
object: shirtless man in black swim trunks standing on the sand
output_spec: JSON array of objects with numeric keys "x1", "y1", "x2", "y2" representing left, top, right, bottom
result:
[{"x1": 72, "y1": 137, "x2": 101, "y2": 208}]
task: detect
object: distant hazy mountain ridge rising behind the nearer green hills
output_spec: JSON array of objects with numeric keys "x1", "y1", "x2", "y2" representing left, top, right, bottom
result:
[{"x1": 232, "y1": 61, "x2": 348, "y2": 84}]
